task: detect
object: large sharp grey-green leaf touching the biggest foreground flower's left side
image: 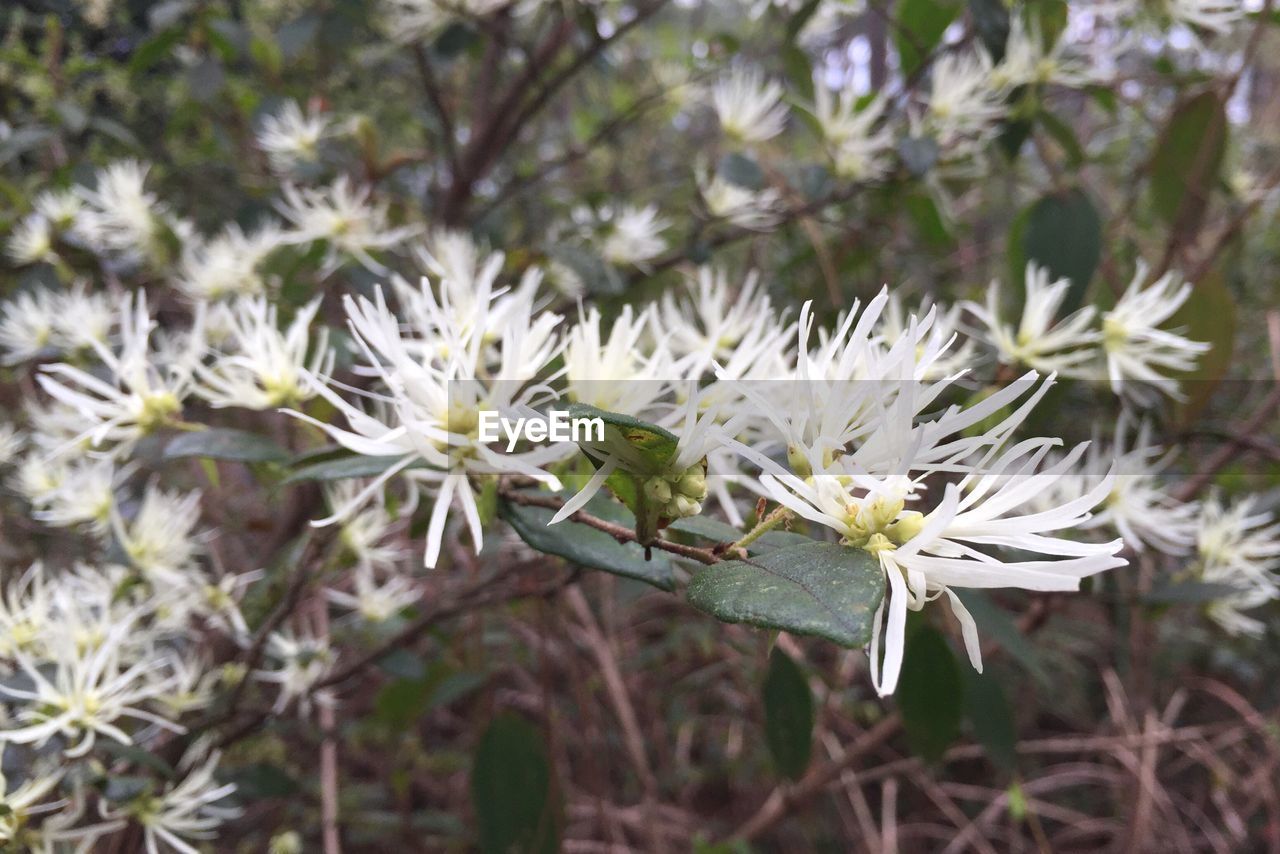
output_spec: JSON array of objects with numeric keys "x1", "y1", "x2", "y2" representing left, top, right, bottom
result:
[{"x1": 687, "y1": 543, "x2": 884, "y2": 647}]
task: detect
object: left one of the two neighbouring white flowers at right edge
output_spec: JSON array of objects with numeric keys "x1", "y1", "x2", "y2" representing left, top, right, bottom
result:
[{"x1": 968, "y1": 261, "x2": 1100, "y2": 376}]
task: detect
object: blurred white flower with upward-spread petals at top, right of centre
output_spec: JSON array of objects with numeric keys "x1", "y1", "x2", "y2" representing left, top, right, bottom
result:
[{"x1": 814, "y1": 85, "x2": 895, "y2": 181}]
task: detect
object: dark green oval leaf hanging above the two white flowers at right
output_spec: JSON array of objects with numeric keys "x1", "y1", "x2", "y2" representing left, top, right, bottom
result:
[{"x1": 1023, "y1": 189, "x2": 1102, "y2": 314}]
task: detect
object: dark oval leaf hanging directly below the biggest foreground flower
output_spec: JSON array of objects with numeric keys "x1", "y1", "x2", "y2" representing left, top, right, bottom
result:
[{"x1": 893, "y1": 624, "x2": 964, "y2": 762}]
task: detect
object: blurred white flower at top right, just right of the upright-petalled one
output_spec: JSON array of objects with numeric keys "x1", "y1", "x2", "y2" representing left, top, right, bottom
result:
[{"x1": 925, "y1": 49, "x2": 1009, "y2": 152}]
